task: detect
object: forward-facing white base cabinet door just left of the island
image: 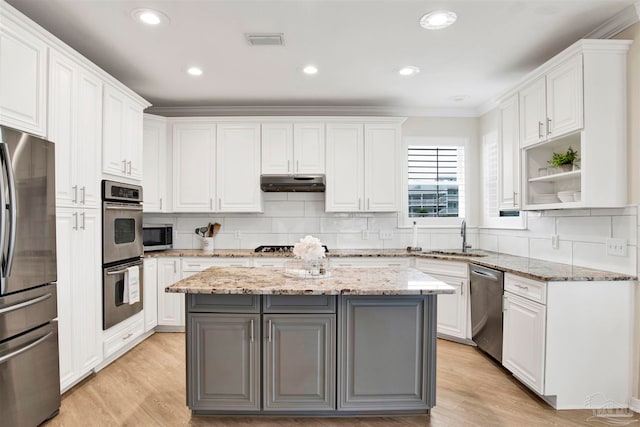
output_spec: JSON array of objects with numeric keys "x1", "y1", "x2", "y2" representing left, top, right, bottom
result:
[{"x1": 158, "y1": 257, "x2": 184, "y2": 331}]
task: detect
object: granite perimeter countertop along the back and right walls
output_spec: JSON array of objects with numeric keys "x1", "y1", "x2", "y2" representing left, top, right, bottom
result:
[{"x1": 145, "y1": 249, "x2": 637, "y2": 282}]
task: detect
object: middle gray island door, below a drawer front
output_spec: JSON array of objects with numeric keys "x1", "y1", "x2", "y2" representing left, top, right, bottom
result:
[{"x1": 263, "y1": 314, "x2": 336, "y2": 411}]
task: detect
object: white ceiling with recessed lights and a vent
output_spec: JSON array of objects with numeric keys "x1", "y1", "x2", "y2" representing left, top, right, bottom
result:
[{"x1": 8, "y1": 0, "x2": 636, "y2": 115}]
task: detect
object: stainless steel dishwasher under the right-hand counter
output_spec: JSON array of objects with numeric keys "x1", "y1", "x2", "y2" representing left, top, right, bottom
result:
[{"x1": 469, "y1": 264, "x2": 504, "y2": 362}]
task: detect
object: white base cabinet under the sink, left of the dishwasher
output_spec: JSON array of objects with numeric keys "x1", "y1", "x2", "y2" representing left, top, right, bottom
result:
[{"x1": 416, "y1": 259, "x2": 471, "y2": 341}]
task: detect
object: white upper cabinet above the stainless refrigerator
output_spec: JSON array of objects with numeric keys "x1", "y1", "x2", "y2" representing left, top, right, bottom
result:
[{"x1": 0, "y1": 8, "x2": 47, "y2": 136}]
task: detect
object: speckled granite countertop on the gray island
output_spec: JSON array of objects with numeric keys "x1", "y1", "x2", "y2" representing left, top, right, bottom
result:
[{"x1": 165, "y1": 267, "x2": 455, "y2": 295}]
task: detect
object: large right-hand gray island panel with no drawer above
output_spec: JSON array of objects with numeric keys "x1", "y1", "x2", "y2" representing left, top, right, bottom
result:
[{"x1": 338, "y1": 296, "x2": 436, "y2": 411}]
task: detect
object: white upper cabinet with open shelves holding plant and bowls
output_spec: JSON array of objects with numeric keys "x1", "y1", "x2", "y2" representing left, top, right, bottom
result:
[{"x1": 520, "y1": 40, "x2": 630, "y2": 210}]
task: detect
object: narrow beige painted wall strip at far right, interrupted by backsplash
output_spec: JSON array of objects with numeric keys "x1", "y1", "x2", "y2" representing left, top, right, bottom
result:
[{"x1": 615, "y1": 23, "x2": 640, "y2": 411}]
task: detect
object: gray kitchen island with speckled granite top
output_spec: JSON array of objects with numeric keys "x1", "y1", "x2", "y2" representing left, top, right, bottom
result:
[{"x1": 166, "y1": 267, "x2": 454, "y2": 416}]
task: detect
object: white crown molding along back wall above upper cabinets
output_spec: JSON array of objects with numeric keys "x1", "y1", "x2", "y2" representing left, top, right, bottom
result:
[{"x1": 145, "y1": 106, "x2": 478, "y2": 117}]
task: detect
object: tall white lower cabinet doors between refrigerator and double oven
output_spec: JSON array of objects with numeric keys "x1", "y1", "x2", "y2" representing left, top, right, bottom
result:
[{"x1": 56, "y1": 209, "x2": 102, "y2": 391}]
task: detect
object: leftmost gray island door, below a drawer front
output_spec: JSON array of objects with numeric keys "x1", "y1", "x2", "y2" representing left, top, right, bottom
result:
[{"x1": 187, "y1": 313, "x2": 260, "y2": 411}]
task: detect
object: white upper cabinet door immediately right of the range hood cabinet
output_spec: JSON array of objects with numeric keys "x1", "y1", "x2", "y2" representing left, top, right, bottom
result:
[{"x1": 325, "y1": 123, "x2": 364, "y2": 212}]
